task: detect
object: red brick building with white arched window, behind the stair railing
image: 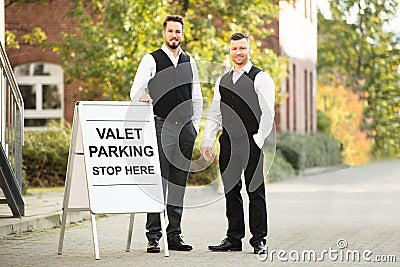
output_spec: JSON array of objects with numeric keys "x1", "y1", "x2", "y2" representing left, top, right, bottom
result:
[{"x1": 5, "y1": 0, "x2": 79, "y2": 127}]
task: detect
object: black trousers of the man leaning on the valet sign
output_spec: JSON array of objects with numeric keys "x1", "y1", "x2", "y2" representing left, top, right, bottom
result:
[{"x1": 146, "y1": 119, "x2": 196, "y2": 240}]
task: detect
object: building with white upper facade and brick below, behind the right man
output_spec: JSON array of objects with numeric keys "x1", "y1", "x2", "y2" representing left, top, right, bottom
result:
[{"x1": 276, "y1": 0, "x2": 317, "y2": 133}]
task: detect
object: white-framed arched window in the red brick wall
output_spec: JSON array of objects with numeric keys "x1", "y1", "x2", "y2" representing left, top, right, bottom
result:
[{"x1": 14, "y1": 62, "x2": 64, "y2": 128}]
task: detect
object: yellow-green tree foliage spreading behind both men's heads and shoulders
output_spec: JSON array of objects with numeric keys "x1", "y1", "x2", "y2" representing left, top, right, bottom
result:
[{"x1": 55, "y1": 0, "x2": 287, "y2": 100}]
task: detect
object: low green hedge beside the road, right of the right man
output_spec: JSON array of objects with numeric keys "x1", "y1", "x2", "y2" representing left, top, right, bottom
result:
[{"x1": 276, "y1": 132, "x2": 342, "y2": 170}]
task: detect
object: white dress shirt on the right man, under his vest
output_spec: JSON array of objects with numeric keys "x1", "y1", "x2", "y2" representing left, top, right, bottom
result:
[{"x1": 202, "y1": 61, "x2": 275, "y2": 151}]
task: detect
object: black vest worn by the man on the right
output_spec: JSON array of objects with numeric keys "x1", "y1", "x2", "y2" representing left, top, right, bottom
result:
[{"x1": 219, "y1": 66, "x2": 262, "y2": 137}]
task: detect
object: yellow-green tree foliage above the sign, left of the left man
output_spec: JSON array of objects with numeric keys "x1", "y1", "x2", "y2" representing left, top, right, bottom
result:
[{"x1": 55, "y1": 0, "x2": 166, "y2": 100}]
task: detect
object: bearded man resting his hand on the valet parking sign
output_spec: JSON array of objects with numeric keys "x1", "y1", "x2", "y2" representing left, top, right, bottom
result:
[{"x1": 130, "y1": 15, "x2": 203, "y2": 253}]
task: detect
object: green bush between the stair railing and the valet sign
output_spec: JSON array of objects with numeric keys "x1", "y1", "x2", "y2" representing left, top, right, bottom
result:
[{"x1": 22, "y1": 125, "x2": 71, "y2": 187}]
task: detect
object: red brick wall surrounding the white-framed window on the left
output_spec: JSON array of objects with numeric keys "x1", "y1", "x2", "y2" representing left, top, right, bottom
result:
[{"x1": 5, "y1": 0, "x2": 79, "y2": 122}]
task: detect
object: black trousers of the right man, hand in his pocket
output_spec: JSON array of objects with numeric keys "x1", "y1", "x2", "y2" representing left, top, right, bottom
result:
[{"x1": 219, "y1": 132, "x2": 268, "y2": 246}]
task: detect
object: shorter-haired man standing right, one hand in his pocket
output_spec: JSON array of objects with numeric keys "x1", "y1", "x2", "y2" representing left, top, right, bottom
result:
[{"x1": 202, "y1": 33, "x2": 275, "y2": 254}]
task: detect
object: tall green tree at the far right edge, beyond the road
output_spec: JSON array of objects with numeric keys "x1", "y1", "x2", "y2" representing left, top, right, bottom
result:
[{"x1": 318, "y1": 0, "x2": 400, "y2": 157}]
